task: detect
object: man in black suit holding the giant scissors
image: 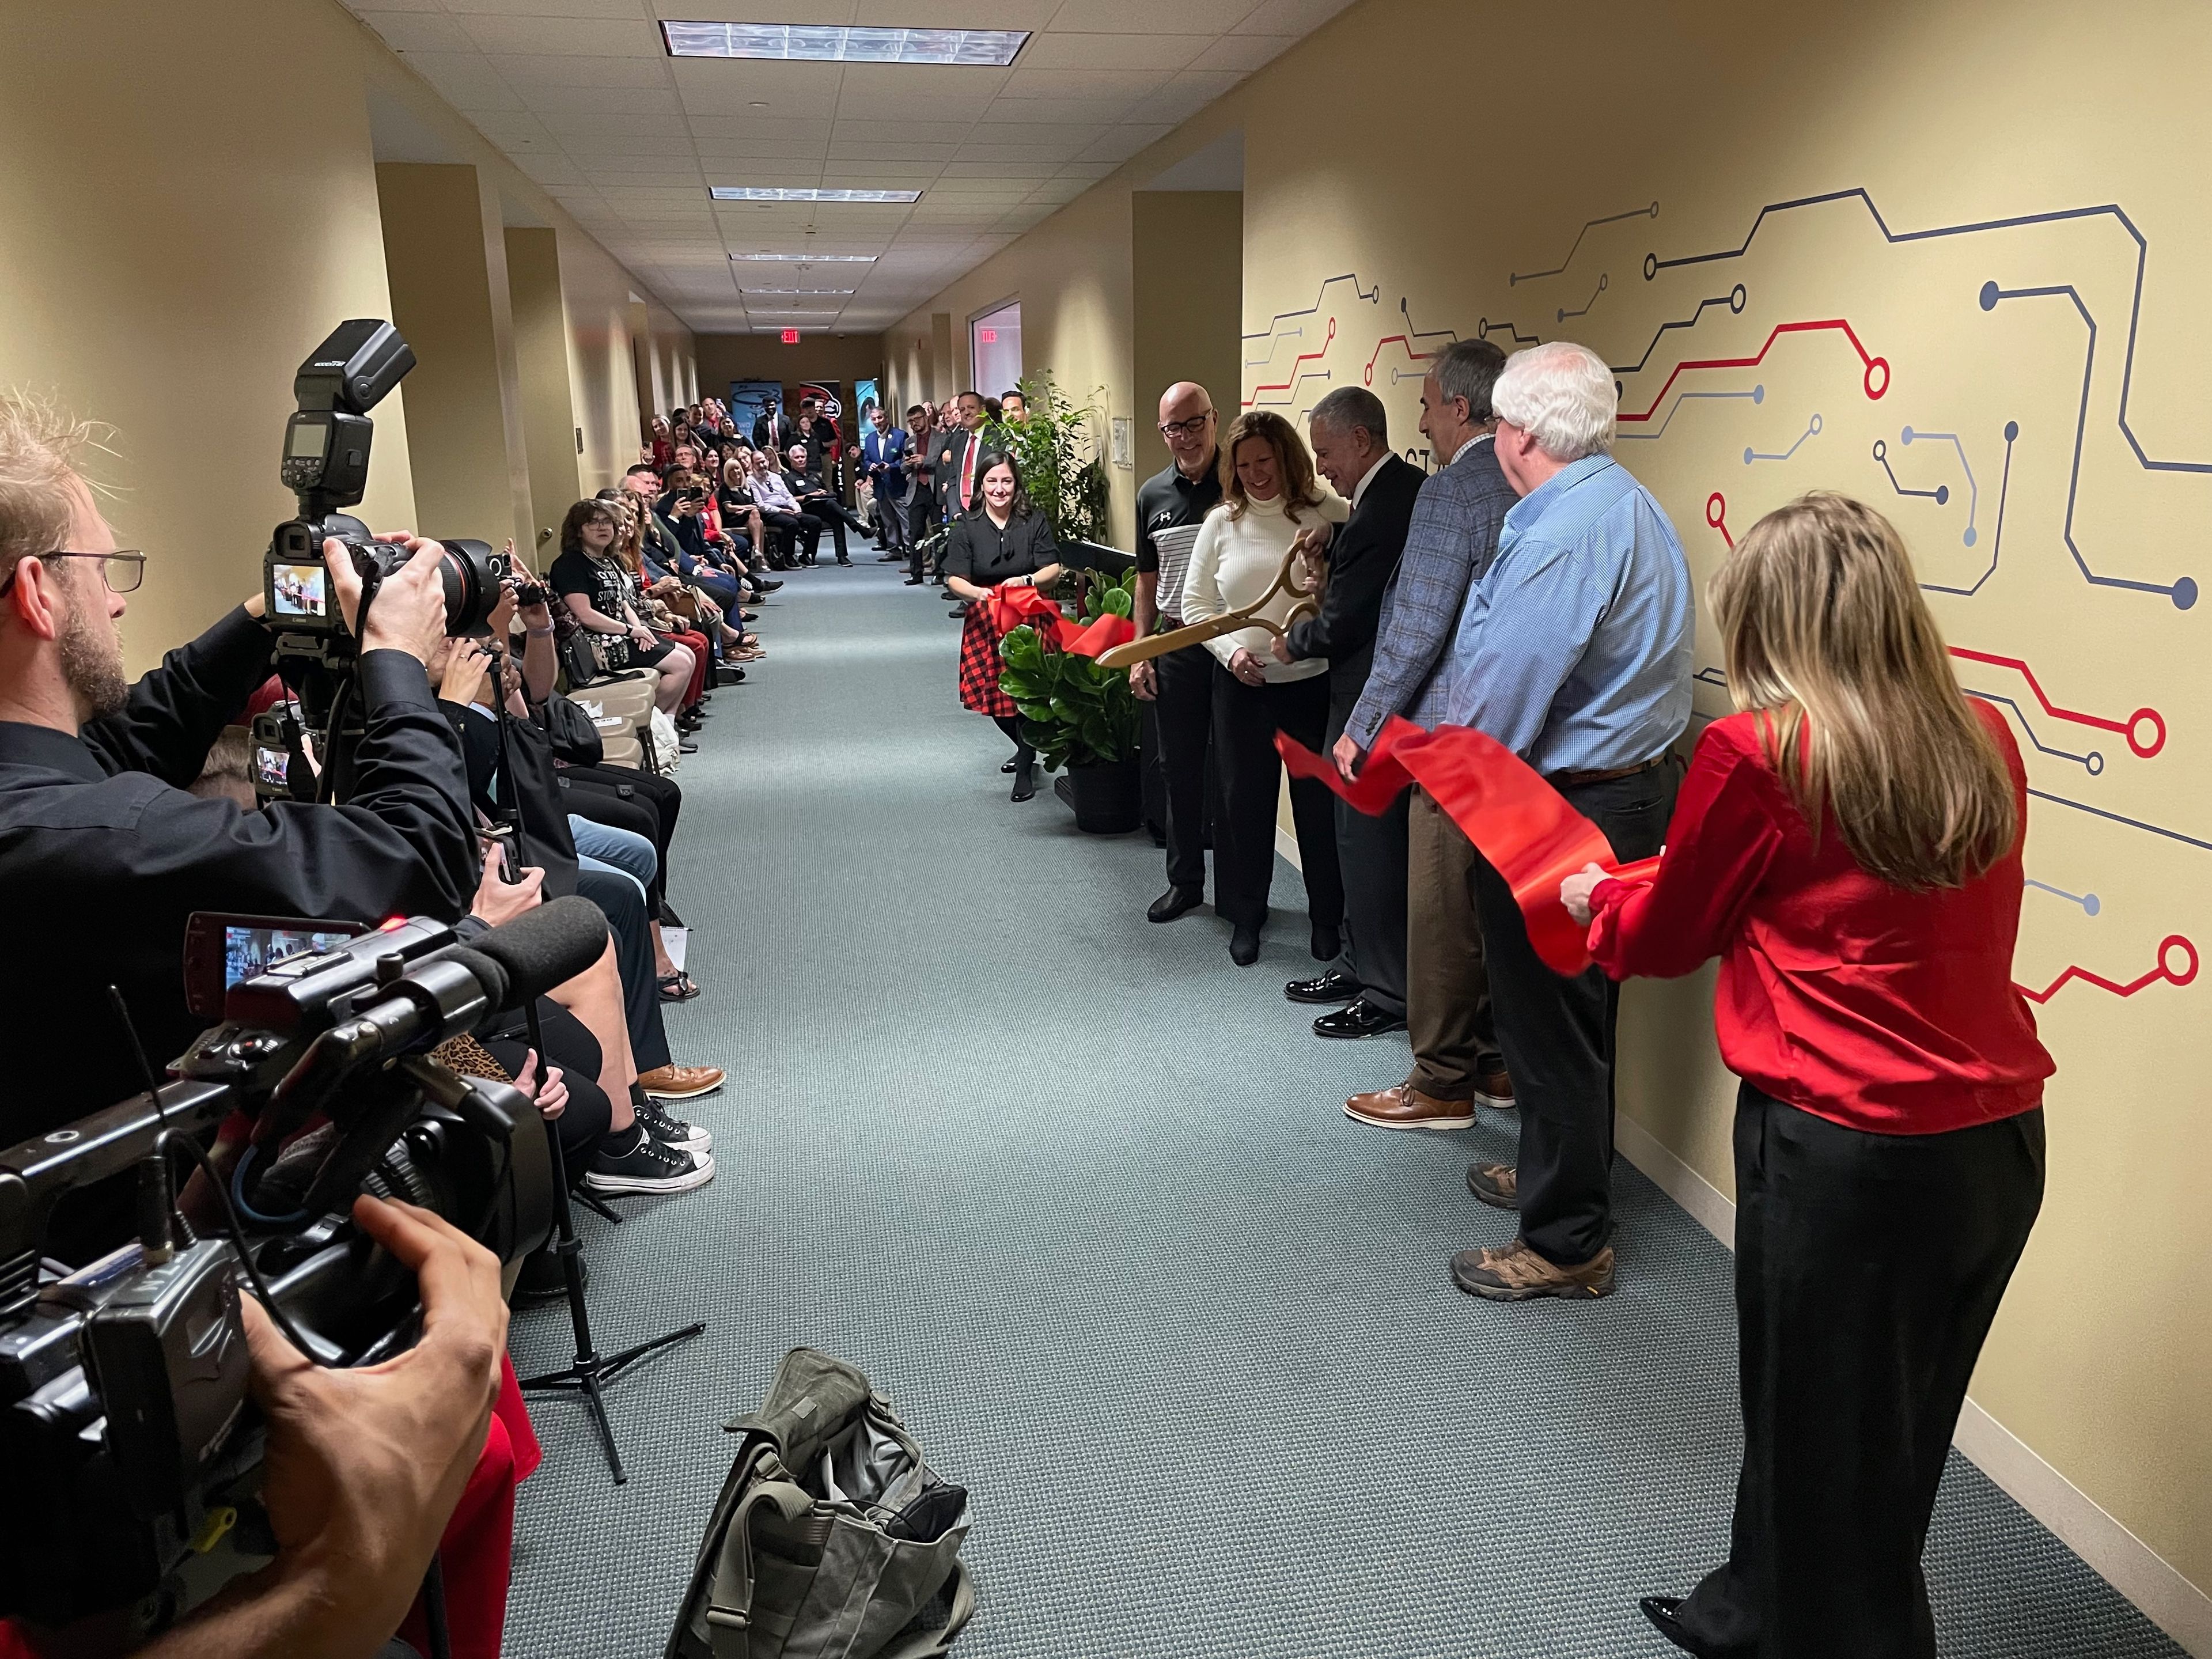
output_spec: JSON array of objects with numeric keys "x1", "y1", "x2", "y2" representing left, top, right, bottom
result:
[{"x1": 1274, "y1": 385, "x2": 1422, "y2": 1037}]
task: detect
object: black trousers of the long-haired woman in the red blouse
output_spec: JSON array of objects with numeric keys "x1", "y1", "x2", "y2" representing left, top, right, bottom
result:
[{"x1": 1672, "y1": 1092, "x2": 2044, "y2": 1659}]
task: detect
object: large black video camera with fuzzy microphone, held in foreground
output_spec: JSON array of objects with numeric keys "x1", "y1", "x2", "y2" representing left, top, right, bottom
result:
[{"x1": 0, "y1": 898, "x2": 606, "y2": 1630}]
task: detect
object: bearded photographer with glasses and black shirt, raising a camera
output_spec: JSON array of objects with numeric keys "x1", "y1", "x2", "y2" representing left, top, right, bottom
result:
[{"x1": 0, "y1": 396, "x2": 478, "y2": 1143}]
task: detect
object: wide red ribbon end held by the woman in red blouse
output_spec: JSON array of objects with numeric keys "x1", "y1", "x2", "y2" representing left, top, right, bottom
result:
[{"x1": 1274, "y1": 714, "x2": 1659, "y2": 974}]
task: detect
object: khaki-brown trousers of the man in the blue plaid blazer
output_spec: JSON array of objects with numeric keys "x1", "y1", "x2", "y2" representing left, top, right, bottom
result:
[{"x1": 1404, "y1": 787, "x2": 1502, "y2": 1099}]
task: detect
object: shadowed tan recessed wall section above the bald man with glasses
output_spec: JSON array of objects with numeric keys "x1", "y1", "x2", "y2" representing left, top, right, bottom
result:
[{"x1": 1130, "y1": 190, "x2": 1247, "y2": 486}]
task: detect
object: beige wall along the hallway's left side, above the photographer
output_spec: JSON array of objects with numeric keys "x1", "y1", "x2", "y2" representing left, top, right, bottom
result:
[{"x1": 0, "y1": 0, "x2": 690, "y2": 671}]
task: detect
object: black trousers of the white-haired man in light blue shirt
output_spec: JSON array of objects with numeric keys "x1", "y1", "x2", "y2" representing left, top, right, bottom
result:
[{"x1": 1475, "y1": 759, "x2": 1681, "y2": 1267}]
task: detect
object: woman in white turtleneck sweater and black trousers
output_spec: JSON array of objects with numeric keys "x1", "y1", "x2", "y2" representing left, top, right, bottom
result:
[{"x1": 1183, "y1": 409, "x2": 1351, "y2": 967}]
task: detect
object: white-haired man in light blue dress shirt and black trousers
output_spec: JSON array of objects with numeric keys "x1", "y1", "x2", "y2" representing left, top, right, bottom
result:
[{"x1": 1445, "y1": 340, "x2": 1696, "y2": 1301}]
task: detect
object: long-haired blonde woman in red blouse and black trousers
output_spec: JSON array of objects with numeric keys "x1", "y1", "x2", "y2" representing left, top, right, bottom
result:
[{"x1": 1559, "y1": 495, "x2": 2053, "y2": 1659}]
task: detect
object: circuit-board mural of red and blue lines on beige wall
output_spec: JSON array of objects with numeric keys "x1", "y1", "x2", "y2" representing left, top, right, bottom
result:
[{"x1": 1241, "y1": 188, "x2": 2212, "y2": 1013}]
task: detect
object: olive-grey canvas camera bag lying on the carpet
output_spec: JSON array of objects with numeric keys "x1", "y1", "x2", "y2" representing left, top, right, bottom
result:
[{"x1": 664, "y1": 1347, "x2": 975, "y2": 1659}]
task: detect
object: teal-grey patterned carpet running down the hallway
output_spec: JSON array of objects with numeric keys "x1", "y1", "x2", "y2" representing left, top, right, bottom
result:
[{"x1": 506, "y1": 553, "x2": 2179, "y2": 1659}]
